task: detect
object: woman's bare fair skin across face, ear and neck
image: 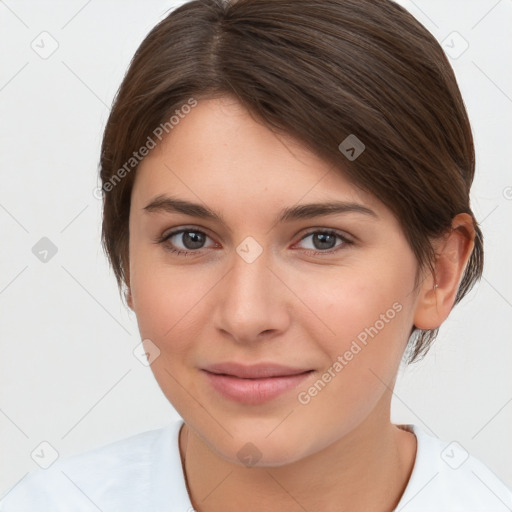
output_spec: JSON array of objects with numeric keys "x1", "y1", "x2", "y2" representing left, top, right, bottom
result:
[{"x1": 129, "y1": 97, "x2": 474, "y2": 512}]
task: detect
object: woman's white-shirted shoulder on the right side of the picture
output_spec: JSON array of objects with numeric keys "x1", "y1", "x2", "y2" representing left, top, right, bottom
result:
[{"x1": 395, "y1": 425, "x2": 512, "y2": 512}]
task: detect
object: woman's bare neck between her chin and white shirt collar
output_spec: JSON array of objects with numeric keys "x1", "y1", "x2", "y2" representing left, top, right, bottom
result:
[{"x1": 180, "y1": 406, "x2": 416, "y2": 512}]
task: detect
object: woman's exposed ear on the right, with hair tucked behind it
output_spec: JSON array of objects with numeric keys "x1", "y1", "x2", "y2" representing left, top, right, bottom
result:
[{"x1": 414, "y1": 213, "x2": 475, "y2": 330}]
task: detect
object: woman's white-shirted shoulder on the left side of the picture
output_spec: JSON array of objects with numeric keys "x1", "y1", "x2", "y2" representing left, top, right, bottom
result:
[{"x1": 0, "y1": 420, "x2": 190, "y2": 512}]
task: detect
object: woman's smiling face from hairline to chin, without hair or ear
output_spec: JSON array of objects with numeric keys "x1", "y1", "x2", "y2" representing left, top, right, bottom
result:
[{"x1": 129, "y1": 97, "x2": 424, "y2": 465}]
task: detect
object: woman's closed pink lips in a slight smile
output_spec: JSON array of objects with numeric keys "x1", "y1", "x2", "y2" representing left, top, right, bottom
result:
[{"x1": 202, "y1": 363, "x2": 313, "y2": 405}]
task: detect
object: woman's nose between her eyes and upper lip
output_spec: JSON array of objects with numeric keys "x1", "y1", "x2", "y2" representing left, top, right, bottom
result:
[{"x1": 213, "y1": 243, "x2": 292, "y2": 344}]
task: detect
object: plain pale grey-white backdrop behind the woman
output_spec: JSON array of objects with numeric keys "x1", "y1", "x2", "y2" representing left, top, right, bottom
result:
[{"x1": 0, "y1": 0, "x2": 512, "y2": 496}]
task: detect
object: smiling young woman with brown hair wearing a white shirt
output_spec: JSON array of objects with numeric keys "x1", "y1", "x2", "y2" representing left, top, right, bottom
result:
[{"x1": 1, "y1": 0, "x2": 512, "y2": 512}]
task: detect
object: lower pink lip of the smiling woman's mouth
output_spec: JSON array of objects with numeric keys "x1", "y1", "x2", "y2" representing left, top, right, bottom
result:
[{"x1": 203, "y1": 370, "x2": 313, "y2": 405}]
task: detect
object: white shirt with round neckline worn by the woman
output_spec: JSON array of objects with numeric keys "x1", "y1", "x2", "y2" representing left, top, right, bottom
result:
[{"x1": 0, "y1": 419, "x2": 512, "y2": 512}]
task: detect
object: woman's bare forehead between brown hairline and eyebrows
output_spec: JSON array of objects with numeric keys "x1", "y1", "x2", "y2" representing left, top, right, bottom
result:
[{"x1": 132, "y1": 97, "x2": 382, "y2": 217}]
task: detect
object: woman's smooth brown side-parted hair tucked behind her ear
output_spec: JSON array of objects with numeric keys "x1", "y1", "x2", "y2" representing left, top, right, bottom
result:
[{"x1": 100, "y1": 0, "x2": 483, "y2": 362}]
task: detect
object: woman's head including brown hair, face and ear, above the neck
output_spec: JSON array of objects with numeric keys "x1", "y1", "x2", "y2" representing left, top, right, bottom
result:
[{"x1": 101, "y1": 0, "x2": 483, "y2": 464}]
